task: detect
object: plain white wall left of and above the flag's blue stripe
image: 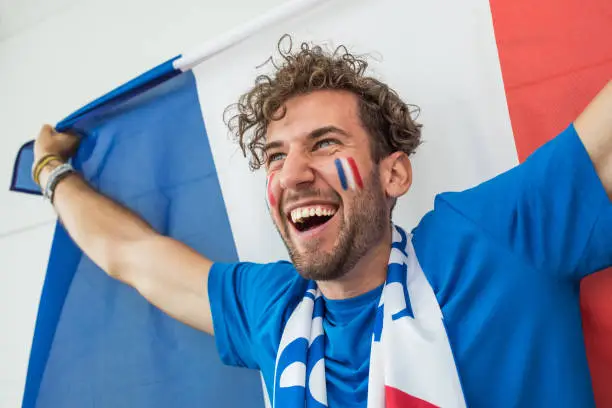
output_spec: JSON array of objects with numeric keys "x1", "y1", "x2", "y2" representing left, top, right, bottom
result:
[{"x1": 0, "y1": 0, "x2": 286, "y2": 408}]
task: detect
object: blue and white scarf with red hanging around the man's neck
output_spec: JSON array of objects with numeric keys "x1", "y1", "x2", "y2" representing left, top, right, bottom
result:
[{"x1": 264, "y1": 226, "x2": 465, "y2": 408}]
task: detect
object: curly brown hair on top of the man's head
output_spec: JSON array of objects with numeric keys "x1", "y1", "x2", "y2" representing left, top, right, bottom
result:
[{"x1": 224, "y1": 35, "x2": 421, "y2": 170}]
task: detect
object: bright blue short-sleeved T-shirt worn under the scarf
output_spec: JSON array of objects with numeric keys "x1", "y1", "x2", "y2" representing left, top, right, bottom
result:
[{"x1": 209, "y1": 126, "x2": 612, "y2": 408}]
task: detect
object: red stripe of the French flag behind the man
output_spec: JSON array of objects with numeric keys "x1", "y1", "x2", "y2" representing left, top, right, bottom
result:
[{"x1": 490, "y1": 0, "x2": 612, "y2": 407}]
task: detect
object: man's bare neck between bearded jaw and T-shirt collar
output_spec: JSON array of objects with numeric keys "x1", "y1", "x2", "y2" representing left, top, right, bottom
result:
[{"x1": 317, "y1": 223, "x2": 391, "y2": 299}]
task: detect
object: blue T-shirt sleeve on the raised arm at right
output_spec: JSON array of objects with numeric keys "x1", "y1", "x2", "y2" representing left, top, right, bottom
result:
[{"x1": 437, "y1": 125, "x2": 612, "y2": 279}]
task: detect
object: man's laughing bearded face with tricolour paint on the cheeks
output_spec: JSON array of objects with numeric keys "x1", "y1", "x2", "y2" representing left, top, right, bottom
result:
[{"x1": 266, "y1": 91, "x2": 390, "y2": 280}]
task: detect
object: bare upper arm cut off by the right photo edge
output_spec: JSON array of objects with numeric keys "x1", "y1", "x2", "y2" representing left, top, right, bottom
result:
[{"x1": 574, "y1": 81, "x2": 612, "y2": 200}]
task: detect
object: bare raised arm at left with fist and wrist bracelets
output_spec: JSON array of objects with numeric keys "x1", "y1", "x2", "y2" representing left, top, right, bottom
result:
[{"x1": 34, "y1": 126, "x2": 213, "y2": 334}]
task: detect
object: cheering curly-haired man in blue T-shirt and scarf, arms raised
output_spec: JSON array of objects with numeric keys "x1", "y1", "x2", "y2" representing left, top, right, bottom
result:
[{"x1": 33, "y1": 39, "x2": 612, "y2": 407}]
